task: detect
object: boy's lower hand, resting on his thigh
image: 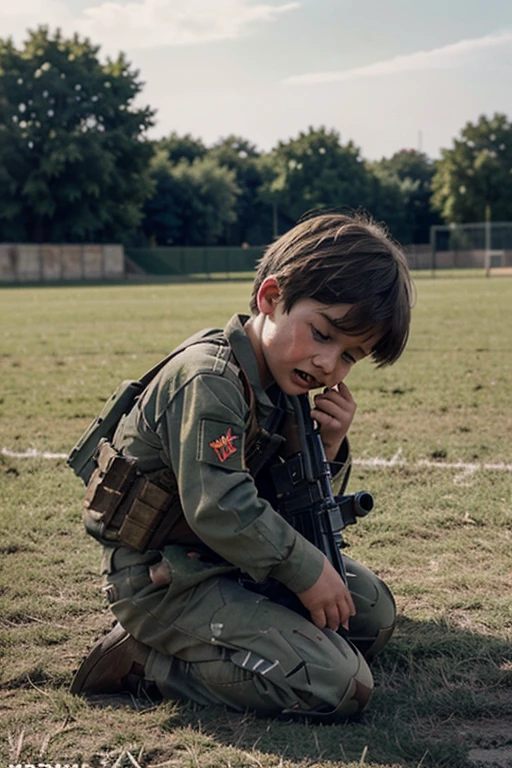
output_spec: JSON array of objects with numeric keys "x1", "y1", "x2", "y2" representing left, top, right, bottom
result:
[{"x1": 297, "y1": 558, "x2": 356, "y2": 631}]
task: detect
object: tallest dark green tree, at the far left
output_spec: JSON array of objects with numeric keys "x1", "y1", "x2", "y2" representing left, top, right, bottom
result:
[{"x1": 0, "y1": 27, "x2": 154, "y2": 242}]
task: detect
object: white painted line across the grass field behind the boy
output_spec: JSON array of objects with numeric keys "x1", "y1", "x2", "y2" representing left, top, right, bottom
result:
[{"x1": 0, "y1": 448, "x2": 512, "y2": 474}]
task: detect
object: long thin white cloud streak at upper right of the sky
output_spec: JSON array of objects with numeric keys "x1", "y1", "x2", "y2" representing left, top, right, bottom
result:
[{"x1": 282, "y1": 31, "x2": 512, "y2": 85}]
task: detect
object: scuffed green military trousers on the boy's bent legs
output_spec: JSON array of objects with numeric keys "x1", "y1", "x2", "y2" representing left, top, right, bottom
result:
[{"x1": 107, "y1": 546, "x2": 395, "y2": 720}]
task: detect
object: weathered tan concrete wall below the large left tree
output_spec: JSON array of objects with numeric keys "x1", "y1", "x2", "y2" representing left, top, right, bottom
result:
[{"x1": 0, "y1": 243, "x2": 125, "y2": 283}]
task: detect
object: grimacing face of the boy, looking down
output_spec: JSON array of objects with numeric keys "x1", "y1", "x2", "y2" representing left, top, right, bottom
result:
[{"x1": 258, "y1": 280, "x2": 378, "y2": 395}]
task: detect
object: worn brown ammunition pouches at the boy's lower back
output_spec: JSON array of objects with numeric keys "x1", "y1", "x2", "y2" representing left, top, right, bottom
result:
[{"x1": 83, "y1": 439, "x2": 183, "y2": 552}]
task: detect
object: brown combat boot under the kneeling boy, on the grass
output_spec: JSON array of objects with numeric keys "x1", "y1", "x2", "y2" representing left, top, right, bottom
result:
[{"x1": 71, "y1": 624, "x2": 151, "y2": 695}]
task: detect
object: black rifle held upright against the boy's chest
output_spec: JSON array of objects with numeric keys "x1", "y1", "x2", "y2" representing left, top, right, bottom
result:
[{"x1": 243, "y1": 395, "x2": 373, "y2": 620}]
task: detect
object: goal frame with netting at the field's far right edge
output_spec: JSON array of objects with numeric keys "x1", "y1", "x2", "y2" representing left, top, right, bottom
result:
[{"x1": 430, "y1": 221, "x2": 512, "y2": 276}]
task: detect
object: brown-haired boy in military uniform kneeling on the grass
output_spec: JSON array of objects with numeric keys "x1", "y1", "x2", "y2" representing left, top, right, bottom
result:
[{"x1": 72, "y1": 214, "x2": 412, "y2": 720}]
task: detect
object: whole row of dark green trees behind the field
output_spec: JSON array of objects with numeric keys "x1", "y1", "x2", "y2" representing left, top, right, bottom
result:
[{"x1": 0, "y1": 26, "x2": 512, "y2": 246}]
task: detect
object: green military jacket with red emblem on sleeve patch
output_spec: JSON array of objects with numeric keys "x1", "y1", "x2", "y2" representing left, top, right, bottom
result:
[{"x1": 106, "y1": 315, "x2": 350, "y2": 592}]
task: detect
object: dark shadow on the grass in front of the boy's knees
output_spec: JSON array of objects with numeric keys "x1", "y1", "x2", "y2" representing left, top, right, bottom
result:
[{"x1": 149, "y1": 617, "x2": 512, "y2": 768}]
